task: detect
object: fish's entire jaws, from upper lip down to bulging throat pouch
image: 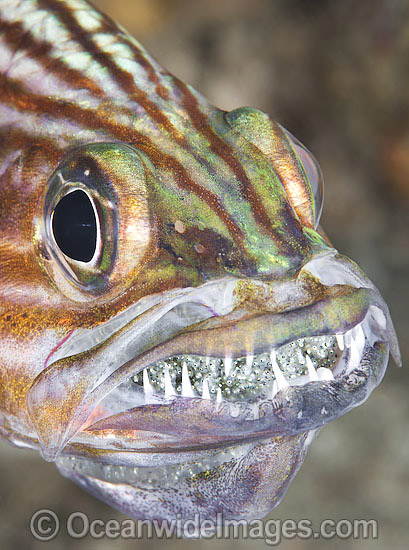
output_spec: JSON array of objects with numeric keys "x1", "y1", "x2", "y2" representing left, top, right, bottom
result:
[{"x1": 23, "y1": 248, "x2": 399, "y2": 520}]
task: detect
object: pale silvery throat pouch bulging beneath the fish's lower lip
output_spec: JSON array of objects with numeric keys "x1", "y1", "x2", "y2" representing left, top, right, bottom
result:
[{"x1": 56, "y1": 432, "x2": 315, "y2": 522}]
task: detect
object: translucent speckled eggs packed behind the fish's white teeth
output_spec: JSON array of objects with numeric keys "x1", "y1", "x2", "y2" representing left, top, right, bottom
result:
[{"x1": 132, "y1": 336, "x2": 340, "y2": 400}]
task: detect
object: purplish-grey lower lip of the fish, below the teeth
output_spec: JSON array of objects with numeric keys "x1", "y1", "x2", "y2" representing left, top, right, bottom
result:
[{"x1": 62, "y1": 342, "x2": 389, "y2": 464}]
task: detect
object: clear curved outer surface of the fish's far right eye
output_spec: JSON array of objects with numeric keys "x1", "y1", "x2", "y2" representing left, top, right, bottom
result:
[{"x1": 285, "y1": 130, "x2": 324, "y2": 229}]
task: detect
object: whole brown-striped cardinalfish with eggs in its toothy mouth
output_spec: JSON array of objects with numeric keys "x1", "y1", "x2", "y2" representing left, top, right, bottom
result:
[{"x1": 0, "y1": 0, "x2": 400, "y2": 519}]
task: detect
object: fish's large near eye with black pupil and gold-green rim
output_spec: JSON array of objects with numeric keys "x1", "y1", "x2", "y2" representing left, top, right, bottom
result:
[{"x1": 35, "y1": 142, "x2": 156, "y2": 302}]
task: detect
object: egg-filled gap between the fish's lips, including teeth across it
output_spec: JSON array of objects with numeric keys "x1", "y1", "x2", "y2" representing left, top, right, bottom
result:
[{"x1": 132, "y1": 335, "x2": 341, "y2": 401}]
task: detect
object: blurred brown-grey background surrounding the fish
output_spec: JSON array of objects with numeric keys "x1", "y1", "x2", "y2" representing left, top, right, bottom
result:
[{"x1": 0, "y1": 0, "x2": 409, "y2": 550}]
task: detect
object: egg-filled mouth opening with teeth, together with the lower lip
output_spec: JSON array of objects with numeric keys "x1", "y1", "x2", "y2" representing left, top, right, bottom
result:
[{"x1": 75, "y1": 306, "x2": 386, "y2": 449}]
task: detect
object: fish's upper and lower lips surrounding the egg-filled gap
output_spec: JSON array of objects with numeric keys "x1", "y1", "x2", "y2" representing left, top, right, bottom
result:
[{"x1": 27, "y1": 249, "x2": 399, "y2": 460}]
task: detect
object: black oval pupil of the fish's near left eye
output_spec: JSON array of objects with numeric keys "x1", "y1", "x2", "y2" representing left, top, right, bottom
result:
[{"x1": 52, "y1": 190, "x2": 97, "y2": 262}]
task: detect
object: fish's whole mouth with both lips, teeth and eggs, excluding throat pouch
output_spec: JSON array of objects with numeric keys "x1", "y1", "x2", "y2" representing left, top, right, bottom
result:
[{"x1": 28, "y1": 252, "x2": 398, "y2": 468}]
